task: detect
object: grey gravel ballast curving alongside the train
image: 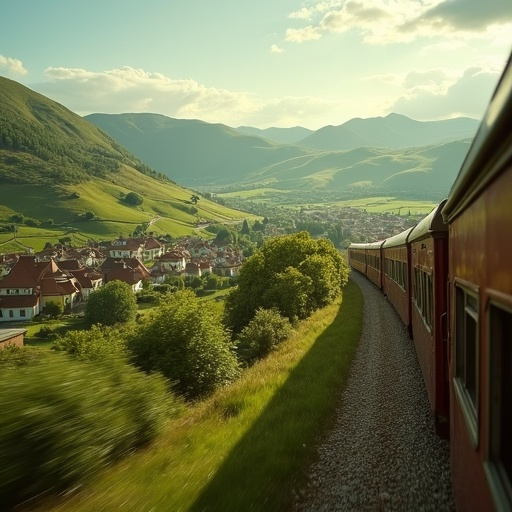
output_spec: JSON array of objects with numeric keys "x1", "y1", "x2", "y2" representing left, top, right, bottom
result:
[{"x1": 294, "y1": 271, "x2": 455, "y2": 512}]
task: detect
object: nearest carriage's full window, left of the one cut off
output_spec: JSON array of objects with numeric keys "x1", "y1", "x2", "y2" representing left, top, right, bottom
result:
[{"x1": 455, "y1": 285, "x2": 479, "y2": 447}]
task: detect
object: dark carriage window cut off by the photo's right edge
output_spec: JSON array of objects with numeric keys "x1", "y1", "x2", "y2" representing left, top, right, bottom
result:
[{"x1": 488, "y1": 303, "x2": 512, "y2": 510}]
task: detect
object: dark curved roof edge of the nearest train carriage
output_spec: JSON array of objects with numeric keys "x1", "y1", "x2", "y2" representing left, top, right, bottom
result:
[{"x1": 443, "y1": 54, "x2": 512, "y2": 222}]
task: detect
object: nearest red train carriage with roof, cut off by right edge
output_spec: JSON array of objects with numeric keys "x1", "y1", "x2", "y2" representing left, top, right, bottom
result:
[{"x1": 443, "y1": 56, "x2": 512, "y2": 512}]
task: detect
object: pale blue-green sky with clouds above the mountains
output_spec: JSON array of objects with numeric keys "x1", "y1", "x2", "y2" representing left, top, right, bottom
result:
[{"x1": 0, "y1": 0, "x2": 512, "y2": 130}]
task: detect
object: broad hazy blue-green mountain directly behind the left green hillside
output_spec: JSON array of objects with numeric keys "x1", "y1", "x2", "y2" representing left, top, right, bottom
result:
[{"x1": 85, "y1": 114, "x2": 310, "y2": 187}]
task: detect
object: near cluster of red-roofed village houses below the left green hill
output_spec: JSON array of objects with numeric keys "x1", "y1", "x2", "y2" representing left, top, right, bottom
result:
[{"x1": 0, "y1": 236, "x2": 243, "y2": 322}]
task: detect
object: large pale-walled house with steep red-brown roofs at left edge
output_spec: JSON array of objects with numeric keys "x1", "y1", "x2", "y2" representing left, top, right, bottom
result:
[{"x1": 0, "y1": 256, "x2": 81, "y2": 322}]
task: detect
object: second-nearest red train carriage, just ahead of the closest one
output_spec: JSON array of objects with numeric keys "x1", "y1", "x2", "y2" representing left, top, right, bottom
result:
[{"x1": 407, "y1": 201, "x2": 449, "y2": 438}]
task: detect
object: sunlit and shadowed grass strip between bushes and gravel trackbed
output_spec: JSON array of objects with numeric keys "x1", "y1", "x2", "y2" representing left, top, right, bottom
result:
[{"x1": 38, "y1": 282, "x2": 362, "y2": 512}]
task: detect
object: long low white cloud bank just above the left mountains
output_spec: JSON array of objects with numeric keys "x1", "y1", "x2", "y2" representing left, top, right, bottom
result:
[{"x1": 31, "y1": 67, "x2": 353, "y2": 128}]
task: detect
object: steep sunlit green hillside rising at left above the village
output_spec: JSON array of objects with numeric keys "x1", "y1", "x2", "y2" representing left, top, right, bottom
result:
[{"x1": 0, "y1": 77, "x2": 252, "y2": 252}]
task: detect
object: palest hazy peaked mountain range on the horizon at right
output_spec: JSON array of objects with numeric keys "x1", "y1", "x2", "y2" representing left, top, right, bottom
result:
[{"x1": 297, "y1": 114, "x2": 479, "y2": 151}]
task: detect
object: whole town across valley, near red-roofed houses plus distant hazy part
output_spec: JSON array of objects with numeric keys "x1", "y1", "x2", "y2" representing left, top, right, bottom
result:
[{"x1": 0, "y1": 207, "x2": 417, "y2": 332}]
